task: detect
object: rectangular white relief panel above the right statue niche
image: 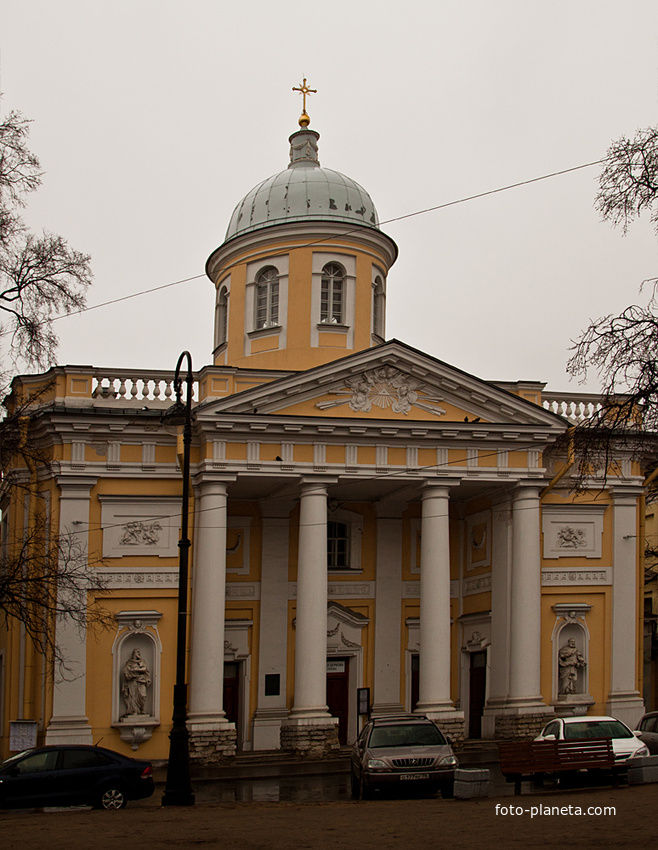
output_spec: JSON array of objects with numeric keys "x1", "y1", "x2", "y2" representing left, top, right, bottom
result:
[{"x1": 542, "y1": 505, "x2": 605, "y2": 558}]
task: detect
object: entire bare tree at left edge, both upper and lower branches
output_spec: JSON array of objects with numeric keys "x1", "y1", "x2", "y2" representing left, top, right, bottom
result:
[{"x1": 0, "y1": 104, "x2": 108, "y2": 666}]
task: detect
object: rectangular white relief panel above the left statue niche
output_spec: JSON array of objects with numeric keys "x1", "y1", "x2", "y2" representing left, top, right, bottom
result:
[{"x1": 99, "y1": 495, "x2": 181, "y2": 558}]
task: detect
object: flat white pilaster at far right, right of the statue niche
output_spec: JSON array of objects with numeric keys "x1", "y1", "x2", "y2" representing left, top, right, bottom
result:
[{"x1": 606, "y1": 486, "x2": 644, "y2": 728}]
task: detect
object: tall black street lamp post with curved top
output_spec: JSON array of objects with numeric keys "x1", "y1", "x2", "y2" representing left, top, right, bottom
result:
[{"x1": 162, "y1": 351, "x2": 194, "y2": 806}]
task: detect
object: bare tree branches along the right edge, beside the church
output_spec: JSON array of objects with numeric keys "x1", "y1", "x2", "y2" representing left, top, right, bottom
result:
[{"x1": 567, "y1": 127, "x2": 658, "y2": 485}]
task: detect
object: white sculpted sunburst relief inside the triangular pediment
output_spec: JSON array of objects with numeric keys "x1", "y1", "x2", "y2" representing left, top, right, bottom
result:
[{"x1": 315, "y1": 366, "x2": 446, "y2": 416}]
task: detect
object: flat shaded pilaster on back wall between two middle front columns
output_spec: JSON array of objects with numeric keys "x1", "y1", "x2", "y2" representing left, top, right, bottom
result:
[{"x1": 372, "y1": 502, "x2": 407, "y2": 714}]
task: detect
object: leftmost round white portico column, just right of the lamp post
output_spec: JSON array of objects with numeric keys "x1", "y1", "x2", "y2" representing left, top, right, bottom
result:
[{"x1": 188, "y1": 481, "x2": 228, "y2": 730}]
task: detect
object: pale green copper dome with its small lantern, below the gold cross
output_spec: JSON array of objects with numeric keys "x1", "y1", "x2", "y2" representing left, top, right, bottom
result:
[{"x1": 226, "y1": 129, "x2": 379, "y2": 241}]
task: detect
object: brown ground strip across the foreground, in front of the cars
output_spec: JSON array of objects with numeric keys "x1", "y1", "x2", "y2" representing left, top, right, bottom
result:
[{"x1": 0, "y1": 784, "x2": 658, "y2": 850}]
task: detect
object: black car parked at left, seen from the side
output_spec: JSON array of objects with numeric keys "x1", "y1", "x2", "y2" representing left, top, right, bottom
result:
[{"x1": 0, "y1": 744, "x2": 154, "y2": 809}]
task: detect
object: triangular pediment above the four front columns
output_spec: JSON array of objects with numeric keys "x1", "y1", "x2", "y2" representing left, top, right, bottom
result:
[{"x1": 208, "y1": 340, "x2": 564, "y2": 430}]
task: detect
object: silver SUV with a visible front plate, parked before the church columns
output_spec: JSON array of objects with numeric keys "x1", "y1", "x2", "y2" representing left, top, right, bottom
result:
[{"x1": 351, "y1": 714, "x2": 458, "y2": 800}]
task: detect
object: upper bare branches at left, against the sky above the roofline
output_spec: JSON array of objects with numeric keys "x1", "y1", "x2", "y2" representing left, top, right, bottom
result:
[{"x1": 0, "y1": 103, "x2": 91, "y2": 381}]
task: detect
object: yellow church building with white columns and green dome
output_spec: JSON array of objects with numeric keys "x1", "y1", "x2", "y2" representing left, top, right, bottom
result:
[{"x1": 0, "y1": 94, "x2": 644, "y2": 762}]
